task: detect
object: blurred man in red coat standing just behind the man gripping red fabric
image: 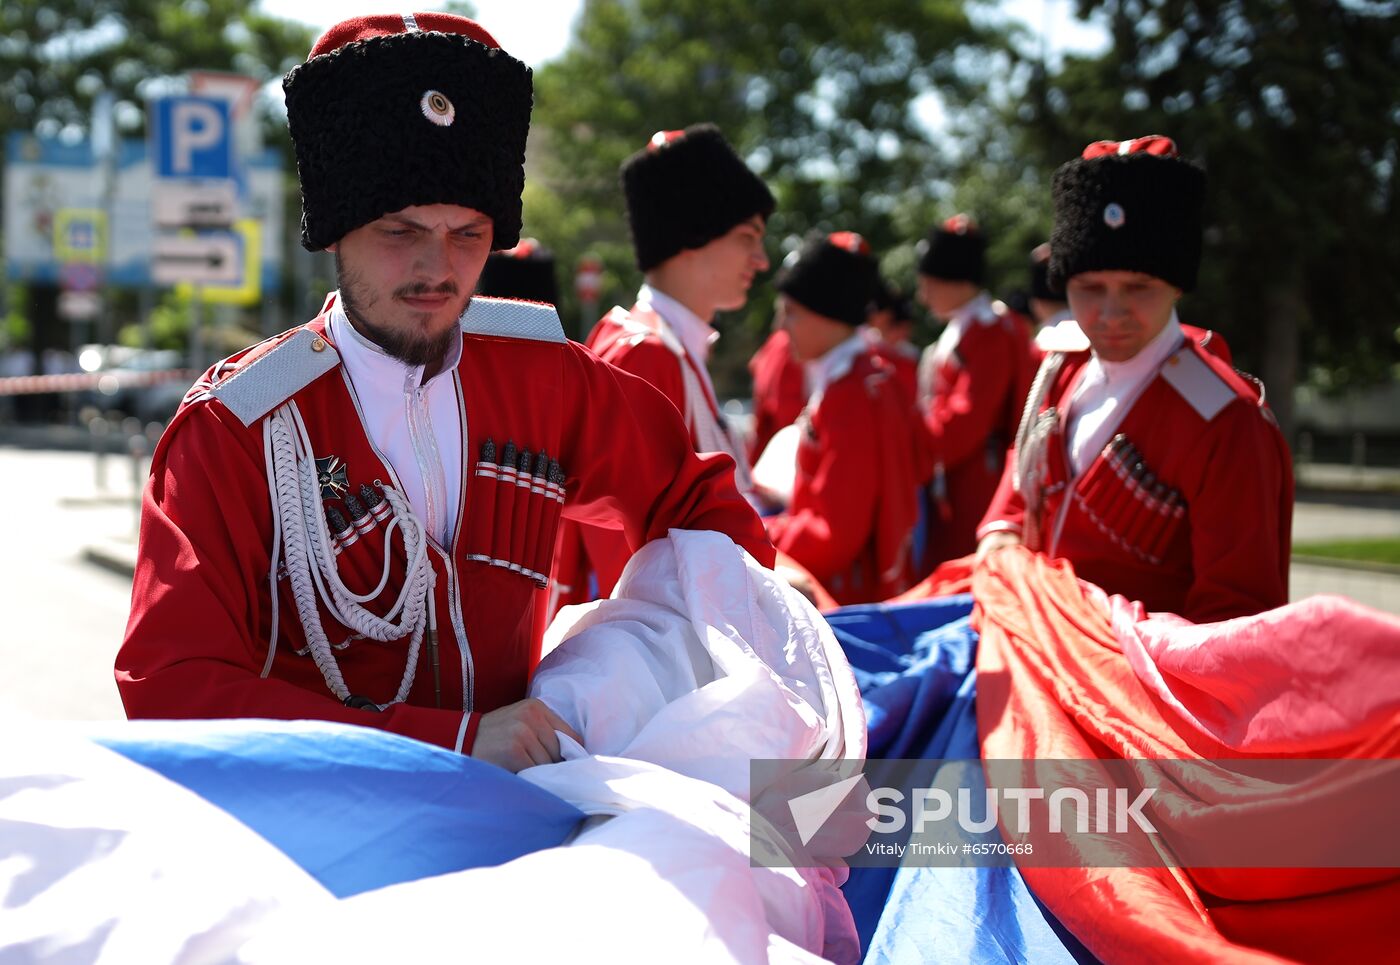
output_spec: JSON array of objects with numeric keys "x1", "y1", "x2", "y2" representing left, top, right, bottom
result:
[{"x1": 918, "y1": 214, "x2": 1033, "y2": 569}]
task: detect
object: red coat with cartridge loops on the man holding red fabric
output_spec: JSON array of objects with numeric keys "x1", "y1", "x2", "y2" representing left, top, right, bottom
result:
[{"x1": 979, "y1": 326, "x2": 1294, "y2": 623}]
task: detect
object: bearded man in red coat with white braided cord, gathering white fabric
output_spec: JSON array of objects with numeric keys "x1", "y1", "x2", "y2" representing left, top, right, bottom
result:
[{"x1": 116, "y1": 14, "x2": 773, "y2": 769}]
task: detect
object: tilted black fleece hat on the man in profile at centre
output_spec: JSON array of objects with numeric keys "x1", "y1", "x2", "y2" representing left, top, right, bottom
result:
[{"x1": 622, "y1": 125, "x2": 774, "y2": 272}]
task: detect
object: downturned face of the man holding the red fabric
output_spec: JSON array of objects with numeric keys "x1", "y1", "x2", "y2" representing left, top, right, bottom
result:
[{"x1": 1065, "y1": 272, "x2": 1182, "y2": 361}]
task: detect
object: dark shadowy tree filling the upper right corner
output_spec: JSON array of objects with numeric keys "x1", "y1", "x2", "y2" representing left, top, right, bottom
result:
[{"x1": 1012, "y1": 0, "x2": 1400, "y2": 429}]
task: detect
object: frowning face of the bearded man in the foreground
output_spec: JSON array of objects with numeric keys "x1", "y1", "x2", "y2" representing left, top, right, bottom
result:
[{"x1": 330, "y1": 204, "x2": 493, "y2": 366}]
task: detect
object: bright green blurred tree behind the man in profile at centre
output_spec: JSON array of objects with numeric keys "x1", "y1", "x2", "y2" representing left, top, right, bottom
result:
[{"x1": 525, "y1": 0, "x2": 1000, "y2": 391}]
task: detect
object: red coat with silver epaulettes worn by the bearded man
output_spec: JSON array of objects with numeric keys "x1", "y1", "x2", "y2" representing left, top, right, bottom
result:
[{"x1": 116, "y1": 300, "x2": 774, "y2": 752}]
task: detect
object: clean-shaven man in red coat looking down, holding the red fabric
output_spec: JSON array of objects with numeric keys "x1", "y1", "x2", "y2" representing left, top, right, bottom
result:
[{"x1": 979, "y1": 136, "x2": 1294, "y2": 622}]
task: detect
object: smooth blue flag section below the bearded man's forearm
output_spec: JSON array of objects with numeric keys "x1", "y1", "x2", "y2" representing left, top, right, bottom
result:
[{"x1": 85, "y1": 720, "x2": 584, "y2": 898}]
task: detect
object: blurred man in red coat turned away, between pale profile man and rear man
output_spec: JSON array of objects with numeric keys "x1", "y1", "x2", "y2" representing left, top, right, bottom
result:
[{"x1": 767, "y1": 231, "x2": 918, "y2": 605}]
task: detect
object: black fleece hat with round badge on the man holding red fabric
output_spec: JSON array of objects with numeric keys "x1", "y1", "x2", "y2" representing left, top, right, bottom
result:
[{"x1": 1049, "y1": 134, "x2": 1205, "y2": 291}]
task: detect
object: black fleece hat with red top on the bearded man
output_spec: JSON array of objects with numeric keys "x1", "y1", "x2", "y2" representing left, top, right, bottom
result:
[{"x1": 281, "y1": 14, "x2": 532, "y2": 251}]
